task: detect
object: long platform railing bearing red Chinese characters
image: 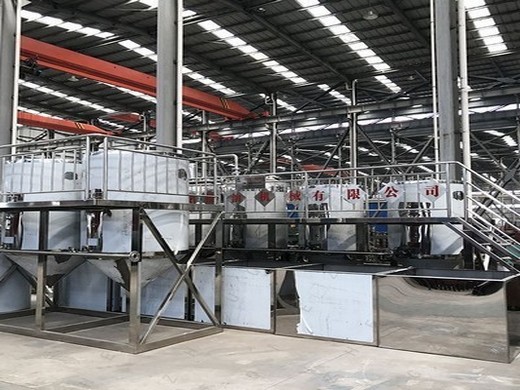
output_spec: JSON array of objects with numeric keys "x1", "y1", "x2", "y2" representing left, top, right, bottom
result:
[{"x1": 220, "y1": 162, "x2": 467, "y2": 219}]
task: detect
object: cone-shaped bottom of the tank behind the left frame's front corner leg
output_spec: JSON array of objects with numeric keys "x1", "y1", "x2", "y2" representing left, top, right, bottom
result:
[{"x1": 87, "y1": 257, "x2": 173, "y2": 291}]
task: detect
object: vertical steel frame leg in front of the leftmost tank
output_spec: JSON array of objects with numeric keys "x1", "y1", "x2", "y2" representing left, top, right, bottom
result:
[{"x1": 35, "y1": 210, "x2": 49, "y2": 330}]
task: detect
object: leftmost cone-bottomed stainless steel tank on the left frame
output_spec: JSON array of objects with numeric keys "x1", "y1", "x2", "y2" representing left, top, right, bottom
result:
[{"x1": 2, "y1": 158, "x2": 84, "y2": 286}]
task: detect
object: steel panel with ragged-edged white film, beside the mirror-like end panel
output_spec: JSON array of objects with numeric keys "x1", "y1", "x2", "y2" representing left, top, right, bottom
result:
[{"x1": 275, "y1": 267, "x2": 377, "y2": 345}]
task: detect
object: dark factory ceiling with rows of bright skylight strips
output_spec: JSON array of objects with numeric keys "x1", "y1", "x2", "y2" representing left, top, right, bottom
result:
[{"x1": 14, "y1": 0, "x2": 520, "y2": 178}]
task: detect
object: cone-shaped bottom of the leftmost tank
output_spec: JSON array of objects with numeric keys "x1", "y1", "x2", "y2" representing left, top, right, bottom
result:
[{"x1": 6, "y1": 252, "x2": 85, "y2": 287}]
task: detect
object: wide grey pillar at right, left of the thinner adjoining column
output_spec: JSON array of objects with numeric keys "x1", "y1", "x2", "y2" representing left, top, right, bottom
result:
[{"x1": 434, "y1": 0, "x2": 461, "y2": 171}]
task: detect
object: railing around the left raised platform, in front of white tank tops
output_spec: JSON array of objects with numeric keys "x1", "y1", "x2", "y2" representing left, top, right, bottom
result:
[{"x1": 0, "y1": 136, "x2": 225, "y2": 203}]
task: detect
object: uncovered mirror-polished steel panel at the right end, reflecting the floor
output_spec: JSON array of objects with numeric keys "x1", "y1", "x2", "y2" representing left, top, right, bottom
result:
[{"x1": 377, "y1": 276, "x2": 510, "y2": 362}]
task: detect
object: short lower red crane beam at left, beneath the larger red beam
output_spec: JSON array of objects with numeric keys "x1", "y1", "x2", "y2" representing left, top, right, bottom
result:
[{"x1": 18, "y1": 111, "x2": 113, "y2": 135}]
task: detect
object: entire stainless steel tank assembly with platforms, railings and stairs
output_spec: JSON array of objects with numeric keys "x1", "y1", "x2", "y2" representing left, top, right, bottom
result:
[{"x1": 0, "y1": 145, "x2": 520, "y2": 361}]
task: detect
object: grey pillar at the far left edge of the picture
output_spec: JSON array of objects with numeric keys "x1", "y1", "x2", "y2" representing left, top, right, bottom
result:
[{"x1": 0, "y1": 0, "x2": 17, "y2": 155}]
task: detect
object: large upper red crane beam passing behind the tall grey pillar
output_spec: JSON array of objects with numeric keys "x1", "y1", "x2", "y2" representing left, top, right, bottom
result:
[{"x1": 21, "y1": 36, "x2": 254, "y2": 119}]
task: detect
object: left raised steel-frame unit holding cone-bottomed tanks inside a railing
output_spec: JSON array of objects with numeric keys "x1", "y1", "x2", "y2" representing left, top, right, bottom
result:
[{"x1": 0, "y1": 136, "x2": 222, "y2": 353}]
